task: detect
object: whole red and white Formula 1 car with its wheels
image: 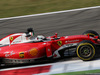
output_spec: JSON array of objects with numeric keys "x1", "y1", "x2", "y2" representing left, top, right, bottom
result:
[{"x1": 0, "y1": 29, "x2": 100, "y2": 63}]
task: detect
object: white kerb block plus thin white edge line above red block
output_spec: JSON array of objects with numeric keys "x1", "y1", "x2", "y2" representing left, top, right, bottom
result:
[{"x1": 0, "y1": 59, "x2": 100, "y2": 75}]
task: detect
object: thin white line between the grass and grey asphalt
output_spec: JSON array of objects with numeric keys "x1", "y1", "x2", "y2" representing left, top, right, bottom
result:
[{"x1": 0, "y1": 6, "x2": 100, "y2": 20}]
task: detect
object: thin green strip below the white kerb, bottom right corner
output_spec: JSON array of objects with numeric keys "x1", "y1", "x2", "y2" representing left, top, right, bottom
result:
[{"x1": 53, "y1": 70, "x2": 100, "y2": 75}]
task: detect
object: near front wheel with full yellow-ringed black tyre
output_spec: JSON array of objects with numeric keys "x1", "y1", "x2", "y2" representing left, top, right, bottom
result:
[{"x1": 76, "y1": 40, "x2": 96, "y2": 61}]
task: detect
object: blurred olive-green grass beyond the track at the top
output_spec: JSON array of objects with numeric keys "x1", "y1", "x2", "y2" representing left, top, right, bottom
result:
[{"x1": 0, "y1": 0, "x2": 100, "y2": 18}]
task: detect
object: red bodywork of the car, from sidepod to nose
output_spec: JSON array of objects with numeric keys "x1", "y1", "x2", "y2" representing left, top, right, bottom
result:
[{"x1": 0, "y1": 34, "x2": 99, "y2": 63}]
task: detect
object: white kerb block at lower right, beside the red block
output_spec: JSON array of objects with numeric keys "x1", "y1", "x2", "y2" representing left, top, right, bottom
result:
[{"x1": 34, "y1": 59, "x2": 100, "y2": 75}]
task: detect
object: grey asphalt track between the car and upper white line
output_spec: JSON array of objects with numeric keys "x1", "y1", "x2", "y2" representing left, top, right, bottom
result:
[{"x1": 0, "y1": 8, "x2": 100, "y2": 39}]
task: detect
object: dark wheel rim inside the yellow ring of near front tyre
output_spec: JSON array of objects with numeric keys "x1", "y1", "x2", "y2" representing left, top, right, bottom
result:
[{"x1": 80, "y1": 46, "x2": 92, "y2": 57}]
